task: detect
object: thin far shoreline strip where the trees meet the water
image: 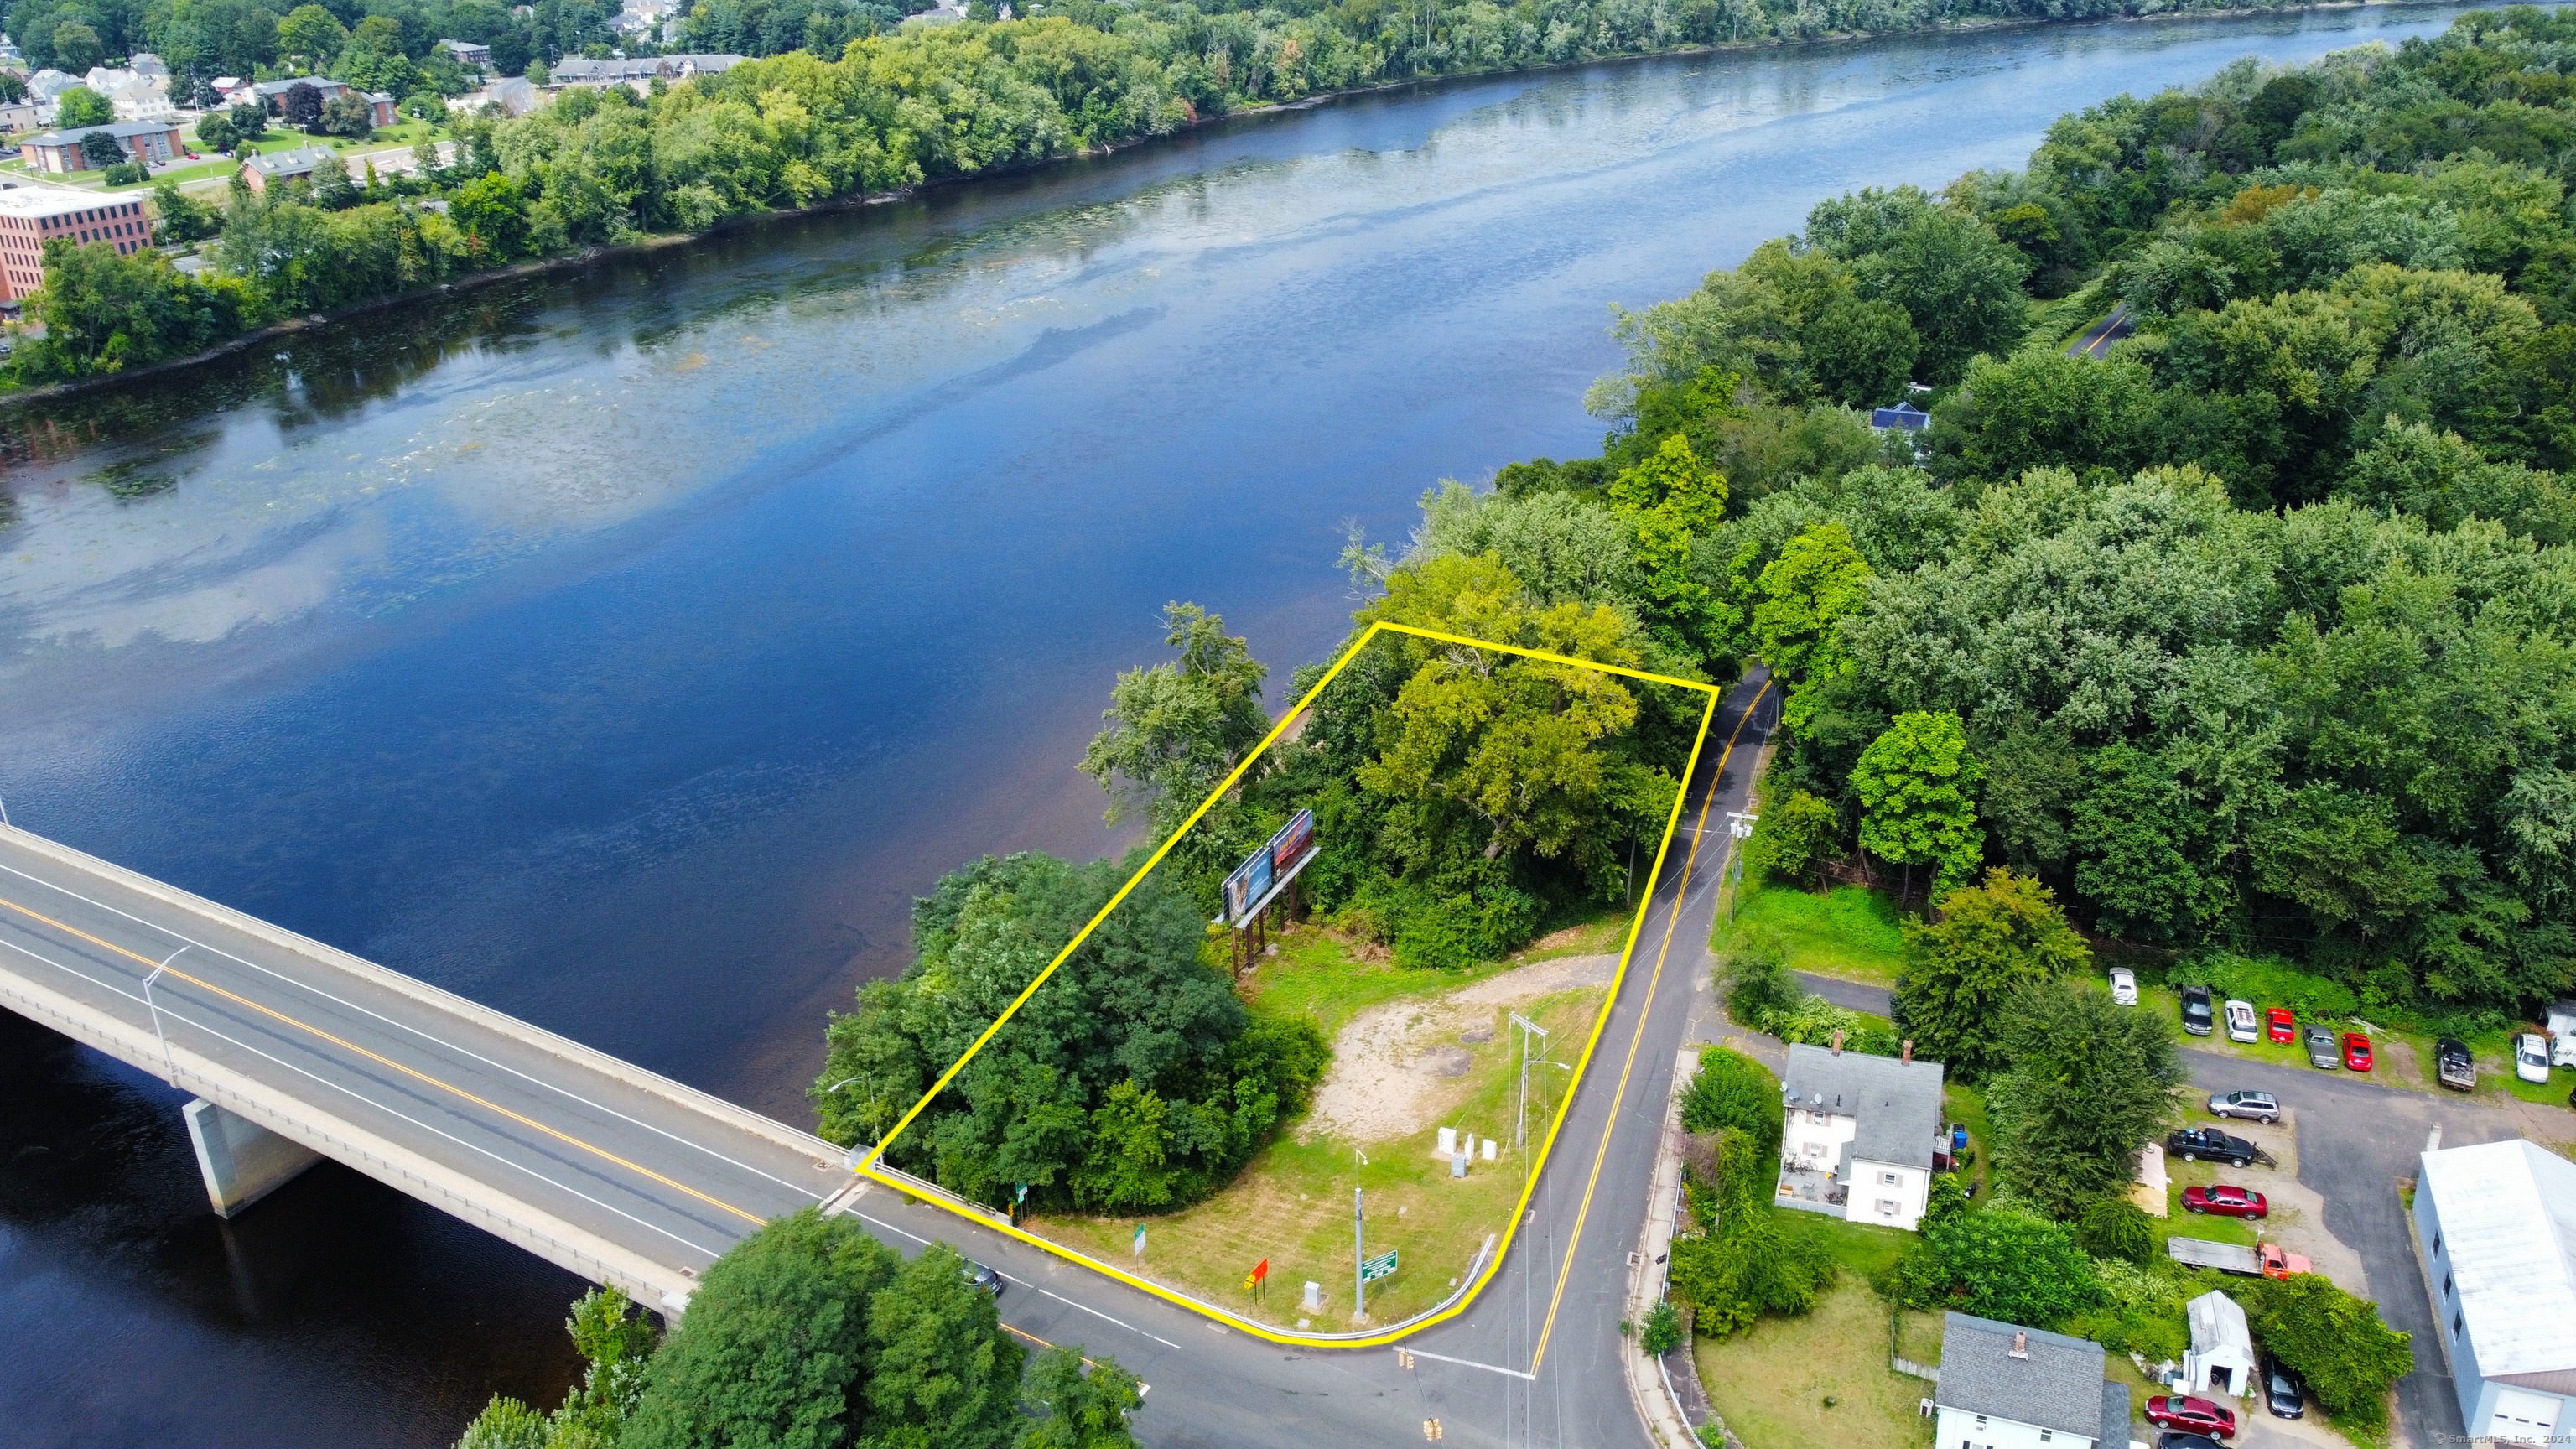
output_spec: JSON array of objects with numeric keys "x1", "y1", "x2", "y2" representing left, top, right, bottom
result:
[{"x1": 0, "y1": 0, "x2": 2449, "y2": 413}]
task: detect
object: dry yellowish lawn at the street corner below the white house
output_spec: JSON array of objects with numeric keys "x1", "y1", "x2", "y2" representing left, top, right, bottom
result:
[{"x1": 1692, "y1": 1273, "x2": 1940, "y2": 1449}]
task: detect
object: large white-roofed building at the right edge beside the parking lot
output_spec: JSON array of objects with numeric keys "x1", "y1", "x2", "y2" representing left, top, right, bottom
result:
[{"x1": 2413, "y1": 1140, "x2": 2576, "y2": 1444}]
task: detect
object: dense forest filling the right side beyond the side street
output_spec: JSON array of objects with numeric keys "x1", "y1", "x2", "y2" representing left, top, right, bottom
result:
[{"x1": 1404, "y1": 10, "x2": 2576, "y2": 1026}]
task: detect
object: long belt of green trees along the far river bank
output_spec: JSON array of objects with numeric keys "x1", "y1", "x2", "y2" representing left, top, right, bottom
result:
[{"x1": 0, "y1": 0, "x2": 2390, "y2": 384}]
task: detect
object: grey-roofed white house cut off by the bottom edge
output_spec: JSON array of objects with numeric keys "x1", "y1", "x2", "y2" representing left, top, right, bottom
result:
[{"x1": 1932, "y1": 1312, "x2": 2127, "y2": 1449}]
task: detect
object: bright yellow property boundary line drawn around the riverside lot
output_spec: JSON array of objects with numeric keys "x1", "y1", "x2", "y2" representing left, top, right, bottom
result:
[{"x1": 853, "y1": 621, "x2": 1731, "y2": 1348}]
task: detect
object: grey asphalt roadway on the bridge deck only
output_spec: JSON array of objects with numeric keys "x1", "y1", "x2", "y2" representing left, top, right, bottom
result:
[{"x1": 0, "y1": 830, "x2": 848, "y2": 1281}]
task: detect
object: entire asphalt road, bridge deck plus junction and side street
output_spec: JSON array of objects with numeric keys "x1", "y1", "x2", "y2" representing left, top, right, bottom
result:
[{"x1": 0, "y1": 676, "x2": 1775, "y2": 1449}]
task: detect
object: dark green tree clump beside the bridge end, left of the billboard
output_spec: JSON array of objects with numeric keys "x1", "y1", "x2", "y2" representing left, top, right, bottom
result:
[{"x1": 814, "y1": 854, "x2": 1324, "y2": 1212}]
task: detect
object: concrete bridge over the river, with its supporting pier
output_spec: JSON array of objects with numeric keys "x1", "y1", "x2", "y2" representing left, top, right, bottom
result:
[{"x1": 0, "y1": 825, "x2": 858, "y2": 1317}]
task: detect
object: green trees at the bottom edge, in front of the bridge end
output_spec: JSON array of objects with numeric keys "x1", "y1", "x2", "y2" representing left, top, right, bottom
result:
[{"x1": 456, "y1": 1209, "x2": 1141, "y2": 1449}]
